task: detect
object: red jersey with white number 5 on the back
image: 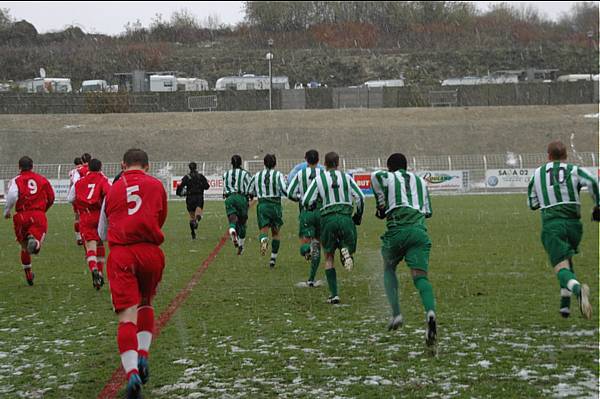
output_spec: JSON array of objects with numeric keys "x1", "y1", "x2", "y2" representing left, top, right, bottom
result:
[{"x1": 104, "y1": 170, "x2": 167, "y2": 245}]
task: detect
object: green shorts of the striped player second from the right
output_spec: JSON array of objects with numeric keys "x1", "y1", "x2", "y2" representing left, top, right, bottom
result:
[{"x1": 381, "y1": 225, "x2": 431, "y2": 272}]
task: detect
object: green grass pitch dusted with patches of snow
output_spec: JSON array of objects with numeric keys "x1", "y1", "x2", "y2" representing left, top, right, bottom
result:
[{"x1": 0, "y1": 195, "x2": 599, "y2": 398}]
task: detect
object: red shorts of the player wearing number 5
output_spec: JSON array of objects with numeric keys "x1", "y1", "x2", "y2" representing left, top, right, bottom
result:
[{"x1": 106, "y1": 243, "x2": 165, "y2": 312}]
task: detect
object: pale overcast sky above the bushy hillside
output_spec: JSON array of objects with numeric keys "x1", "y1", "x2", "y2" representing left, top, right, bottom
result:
[{"x1": 0, "y1": 1, "x2": 574, "y2": 35}]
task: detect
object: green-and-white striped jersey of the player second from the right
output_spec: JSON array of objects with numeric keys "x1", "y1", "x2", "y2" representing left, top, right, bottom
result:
[{"x1": 371, "y1": 170, "x2": 432, "y2": 217}]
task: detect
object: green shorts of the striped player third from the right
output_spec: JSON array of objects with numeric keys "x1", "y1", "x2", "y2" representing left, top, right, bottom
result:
[{"x1": 321, "y1": 213, "x2": 357, "y2": 254}]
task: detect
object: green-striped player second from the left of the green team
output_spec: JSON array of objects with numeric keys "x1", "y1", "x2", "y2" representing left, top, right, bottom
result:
[{"x1": 252, "y1": 154, "x2": 287, "y2": 269}]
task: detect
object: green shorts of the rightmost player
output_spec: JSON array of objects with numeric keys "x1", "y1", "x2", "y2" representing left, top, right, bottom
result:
[{"x1": 542, "y1": 219, "x2": 583, "y2": 267}]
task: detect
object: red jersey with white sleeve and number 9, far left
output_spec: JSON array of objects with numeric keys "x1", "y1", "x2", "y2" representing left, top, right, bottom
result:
[{"x1": 7, "y1": 171, "x2": 54, "y2": 212}]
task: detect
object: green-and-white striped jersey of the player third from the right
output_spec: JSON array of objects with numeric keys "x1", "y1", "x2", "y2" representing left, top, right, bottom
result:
[{"x1": 302, "y1": 170, "x2": 365, "y2": 214}]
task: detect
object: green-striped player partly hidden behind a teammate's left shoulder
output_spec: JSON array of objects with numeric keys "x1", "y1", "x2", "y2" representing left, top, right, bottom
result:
[{"x1": 288, "y1": 150, "x2": 321, "y2": 287}]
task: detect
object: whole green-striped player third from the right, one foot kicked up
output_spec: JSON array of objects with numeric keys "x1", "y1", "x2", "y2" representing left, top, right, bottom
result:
[{"x1": 302, "y1": 152, "x2": 365, "y2": 304}]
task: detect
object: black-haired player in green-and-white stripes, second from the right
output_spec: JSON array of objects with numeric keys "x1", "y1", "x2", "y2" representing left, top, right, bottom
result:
[{"x1": 371, "y1": 153, "x2": 437, "y2": 346}]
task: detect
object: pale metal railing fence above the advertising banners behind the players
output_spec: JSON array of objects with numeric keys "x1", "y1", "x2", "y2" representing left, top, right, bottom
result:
[{"x1": 0, "y1": 152, "x2": 598, "y2": 200}]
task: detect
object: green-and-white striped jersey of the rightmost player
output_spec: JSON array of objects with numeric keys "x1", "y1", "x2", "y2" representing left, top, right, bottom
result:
[{"x1": 528, "y1": 162, "x2": 599, "y2": 210}]
